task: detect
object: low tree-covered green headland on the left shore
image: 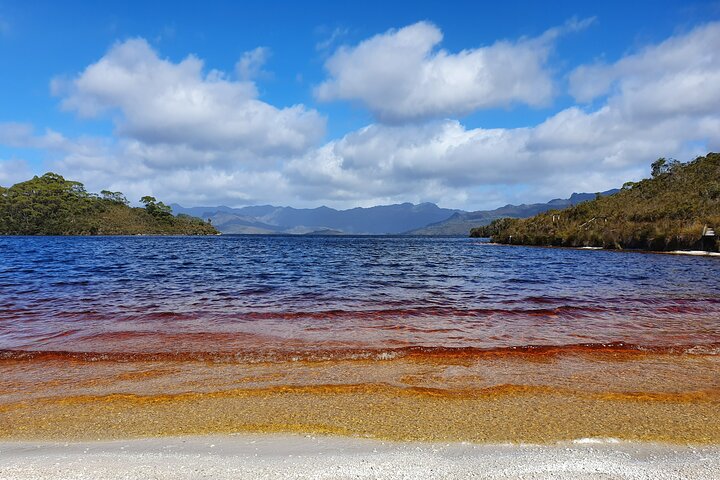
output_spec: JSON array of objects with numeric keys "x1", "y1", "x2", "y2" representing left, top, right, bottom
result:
[{"x1": 0, "y1": 173, "x2": 218, "y2": 235}]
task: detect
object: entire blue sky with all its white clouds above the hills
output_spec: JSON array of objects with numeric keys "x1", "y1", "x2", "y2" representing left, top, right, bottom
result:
[{"x1": 0, "y1": 0, "x2": 720, "y2": 210}]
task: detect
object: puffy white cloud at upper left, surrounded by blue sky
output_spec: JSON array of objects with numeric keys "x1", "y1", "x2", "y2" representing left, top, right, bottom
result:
[{"x1": 53, "y1": 39, "x2": 325, "y2": 156}]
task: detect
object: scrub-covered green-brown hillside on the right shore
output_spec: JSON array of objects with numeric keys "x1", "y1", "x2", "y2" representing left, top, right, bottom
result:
[{"x1": 471, "y1": 153, "x2": 720, "y2": 251}]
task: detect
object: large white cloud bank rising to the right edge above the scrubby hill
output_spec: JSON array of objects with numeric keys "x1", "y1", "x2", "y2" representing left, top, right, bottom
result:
[{"x1": 287, "y1": 24, "x2": 720, "y2": 205}]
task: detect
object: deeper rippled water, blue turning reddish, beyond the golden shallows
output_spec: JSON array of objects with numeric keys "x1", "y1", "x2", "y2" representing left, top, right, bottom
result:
[{"x1": 0, "y1": 236, "x2": 720, "y2": 352}]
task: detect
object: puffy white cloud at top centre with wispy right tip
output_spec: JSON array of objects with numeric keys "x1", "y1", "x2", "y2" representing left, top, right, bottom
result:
[{"x1": 315, "y1": 22, "x2": 564, "y2": 123}]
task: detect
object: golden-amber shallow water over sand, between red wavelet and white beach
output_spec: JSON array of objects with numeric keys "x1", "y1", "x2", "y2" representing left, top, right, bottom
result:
[{"x1": 5, "y1": 347, "x2": 720, "y2": 445}]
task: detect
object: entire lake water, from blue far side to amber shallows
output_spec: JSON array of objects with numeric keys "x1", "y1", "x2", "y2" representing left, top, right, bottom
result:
[{"x1": 0, "y1": 236, "x2": 720, "y2": 441}]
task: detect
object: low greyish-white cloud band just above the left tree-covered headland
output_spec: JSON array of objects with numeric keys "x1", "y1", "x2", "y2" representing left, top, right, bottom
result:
[{"x1": 0, "y1": 124, "x2": 286, "y2": 205}]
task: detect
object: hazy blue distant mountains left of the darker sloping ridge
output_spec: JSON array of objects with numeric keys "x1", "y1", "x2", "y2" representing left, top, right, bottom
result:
[{"x1": 171, "y1": 203, "x2": 458, "y2": 235}]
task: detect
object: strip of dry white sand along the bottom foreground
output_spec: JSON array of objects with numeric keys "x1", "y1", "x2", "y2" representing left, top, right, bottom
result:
[{"x1": 0, "y1": 435, "x2": 720, "y2": 480}]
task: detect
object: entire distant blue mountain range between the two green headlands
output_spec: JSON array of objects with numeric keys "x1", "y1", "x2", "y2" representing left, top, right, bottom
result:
[{"x1": 171, "y1": 190, "x2": 617, "y2": 236}]
